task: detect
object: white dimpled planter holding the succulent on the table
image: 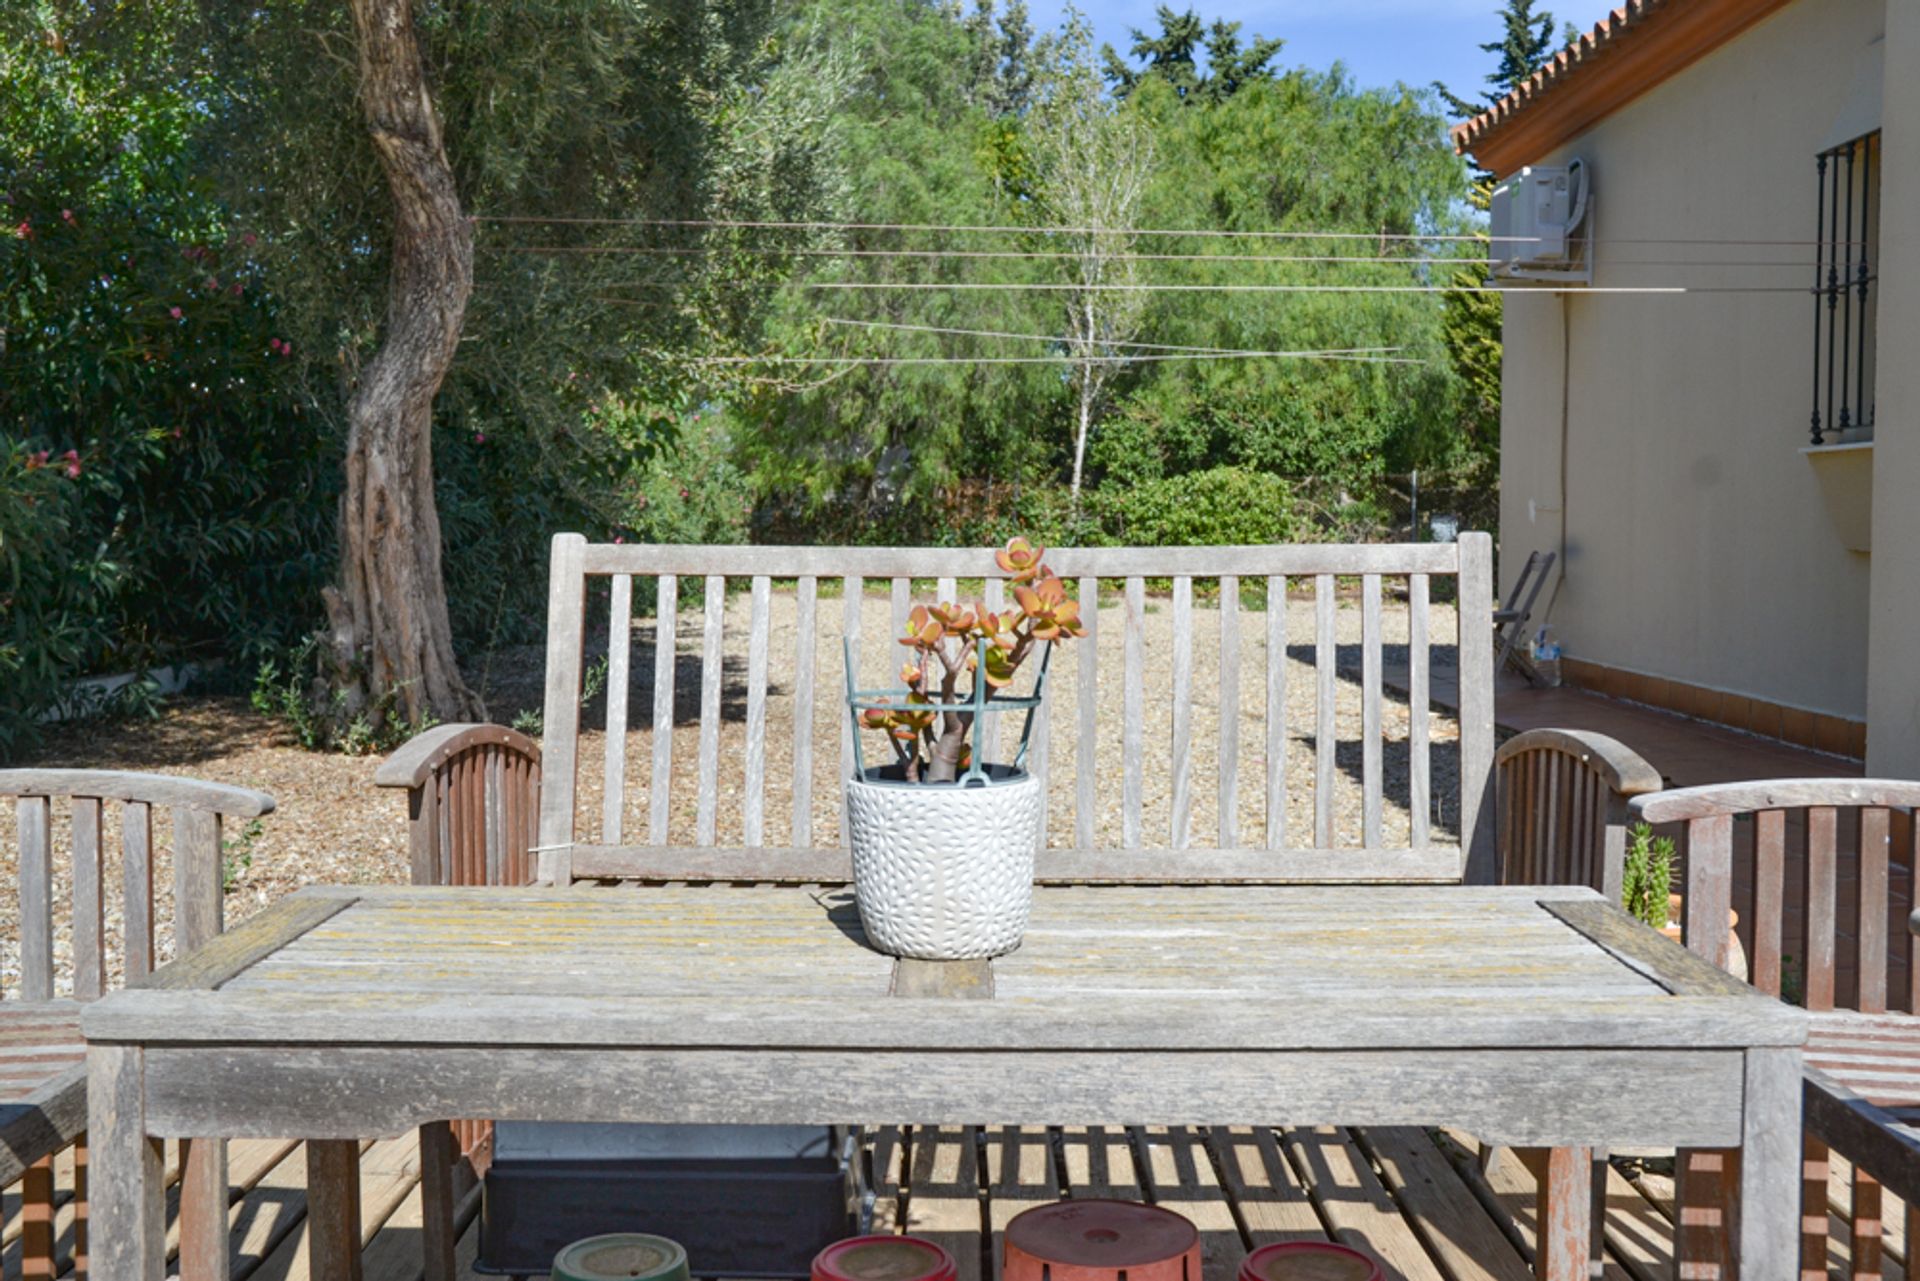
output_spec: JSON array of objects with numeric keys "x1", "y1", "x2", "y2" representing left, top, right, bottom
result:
[{"x1": 847, "y1": 766, "x2": 1043, "y2": 960}]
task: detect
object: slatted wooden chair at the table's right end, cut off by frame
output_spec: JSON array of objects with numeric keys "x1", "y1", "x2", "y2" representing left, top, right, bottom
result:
[{"x1": 1628, "y1": 778, "x2": 1920, "y2": 1281}]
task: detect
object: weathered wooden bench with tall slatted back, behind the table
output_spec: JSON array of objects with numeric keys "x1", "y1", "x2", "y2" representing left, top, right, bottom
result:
[{"x1": 376, "y1": 534, "x2": 1644, "y2": 1281}]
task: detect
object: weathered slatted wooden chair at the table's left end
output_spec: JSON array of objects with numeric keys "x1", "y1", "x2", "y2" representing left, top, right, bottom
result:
[{"x1": 0, "y1": 770, "x2": 273, "y2": 1277}]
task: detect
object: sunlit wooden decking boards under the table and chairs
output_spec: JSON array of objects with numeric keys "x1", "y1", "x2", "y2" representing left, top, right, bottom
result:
[{"x1": 4, "y1": 1129, "x2": 1907, "y2": 1281}]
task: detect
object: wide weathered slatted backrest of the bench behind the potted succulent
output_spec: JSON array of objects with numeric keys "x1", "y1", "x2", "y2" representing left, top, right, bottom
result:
[{"x1": 540, "y1": 534, "x2": 1494, "y2": 882}]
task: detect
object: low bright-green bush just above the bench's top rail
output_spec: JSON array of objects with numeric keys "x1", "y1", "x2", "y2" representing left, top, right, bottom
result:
[{"x1": 1092, "y1": 467, "x2": 1298, "y2": 547}]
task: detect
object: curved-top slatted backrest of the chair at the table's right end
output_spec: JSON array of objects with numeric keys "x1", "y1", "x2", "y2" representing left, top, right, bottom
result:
[{"x1": 1628, "y1": 778, "x2": 1920, "y2": 1014}]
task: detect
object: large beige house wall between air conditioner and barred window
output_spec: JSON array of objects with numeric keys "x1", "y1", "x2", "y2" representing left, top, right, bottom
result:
[{"x1": 1500, "y1": 0, "x2": 1881, "y2": 718}]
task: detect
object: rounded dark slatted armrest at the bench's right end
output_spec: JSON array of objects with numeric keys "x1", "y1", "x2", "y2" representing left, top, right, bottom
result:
[{"x1": 1494, "y1": 730, "x2": 1661, "y2": 903}]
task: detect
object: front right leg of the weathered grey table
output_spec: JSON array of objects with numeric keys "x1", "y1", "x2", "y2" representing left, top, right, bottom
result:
[{"x1": 1734, "y1": 1049, "x2": 1801, "y2": 1281}]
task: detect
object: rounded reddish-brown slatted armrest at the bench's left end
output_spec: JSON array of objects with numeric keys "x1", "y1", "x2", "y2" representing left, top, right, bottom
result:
[{"x1": 372, "y1": 724, "x2": 540, "y2": 885}]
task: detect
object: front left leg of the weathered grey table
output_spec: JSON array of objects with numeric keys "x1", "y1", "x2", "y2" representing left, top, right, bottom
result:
[{"x1": 86, "y1": 1045, "x2": 167, "y2": 1281}]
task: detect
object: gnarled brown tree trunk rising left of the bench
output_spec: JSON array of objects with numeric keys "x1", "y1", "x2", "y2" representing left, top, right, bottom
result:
[{"x1": 326, "y1": 0, "x2": 484, "y2": 722}]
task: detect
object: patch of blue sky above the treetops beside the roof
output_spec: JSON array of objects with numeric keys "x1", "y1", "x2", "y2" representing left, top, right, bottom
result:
[{"x1": 1029, "y1": 0, "x2": 1609, "y2": 112}]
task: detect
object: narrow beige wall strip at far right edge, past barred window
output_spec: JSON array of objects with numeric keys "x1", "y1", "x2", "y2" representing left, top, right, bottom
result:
[{"x1": 1866, "y1": 0, "x2": 1920, "y2": 778}]
